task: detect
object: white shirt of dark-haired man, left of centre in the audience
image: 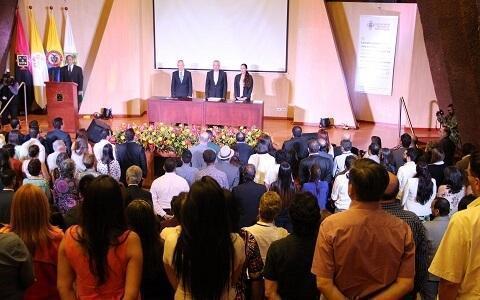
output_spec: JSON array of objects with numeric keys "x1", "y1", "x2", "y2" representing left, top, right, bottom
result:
[{"x1": 150, "y1": 172, "x2": 190, "y2": 217}]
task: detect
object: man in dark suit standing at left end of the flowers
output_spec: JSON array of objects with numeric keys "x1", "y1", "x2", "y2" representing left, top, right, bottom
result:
[{"x1": 116, "y1": 128, "x2": 147, "y2": 182}]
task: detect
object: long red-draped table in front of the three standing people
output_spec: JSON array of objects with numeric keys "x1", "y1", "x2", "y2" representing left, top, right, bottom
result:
[{"x1": 147, "y1": 97, "x2": 263, "y2": 129}]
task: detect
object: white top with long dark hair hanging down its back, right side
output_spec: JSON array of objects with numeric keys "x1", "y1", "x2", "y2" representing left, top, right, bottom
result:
[{"x1": 402, "y1": 178, "x2": 437, "y2": 217}]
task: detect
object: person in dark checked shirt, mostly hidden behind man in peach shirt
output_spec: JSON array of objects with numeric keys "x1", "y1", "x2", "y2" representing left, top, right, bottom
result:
[{"x1": 380, "y1": 172, "x2": 428, "y2": 295}]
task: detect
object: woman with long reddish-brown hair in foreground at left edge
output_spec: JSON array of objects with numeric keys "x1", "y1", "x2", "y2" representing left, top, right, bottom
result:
[{"x1": 0, "y1": 184, "x2": 63, "y2": 299}]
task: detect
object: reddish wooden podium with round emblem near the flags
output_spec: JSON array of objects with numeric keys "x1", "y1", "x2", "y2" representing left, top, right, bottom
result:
[{"x1": 45, "y1": 82, "x2": 78, "y2": 133}]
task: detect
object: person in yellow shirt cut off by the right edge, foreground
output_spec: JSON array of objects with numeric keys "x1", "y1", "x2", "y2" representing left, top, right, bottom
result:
[{"x1": 429, "y1": 152, "x2": 480, "y2": 299}]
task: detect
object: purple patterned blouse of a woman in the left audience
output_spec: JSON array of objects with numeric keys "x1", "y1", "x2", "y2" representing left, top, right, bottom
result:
[{"x1": 53, "y1": 177, "x2": 79, "y2": 214}]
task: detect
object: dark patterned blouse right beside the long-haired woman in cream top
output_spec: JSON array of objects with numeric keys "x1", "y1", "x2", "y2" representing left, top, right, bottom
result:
[{"x1": 235, "y1": 229, "x2": 263, "y2": 300}]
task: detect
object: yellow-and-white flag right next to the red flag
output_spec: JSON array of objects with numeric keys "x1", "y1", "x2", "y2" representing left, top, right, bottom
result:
[{"x1": 28, "y1": 8, "x2": 48, "y2": 109}]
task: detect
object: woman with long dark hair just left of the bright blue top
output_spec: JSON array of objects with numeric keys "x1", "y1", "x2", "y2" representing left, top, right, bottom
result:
[{"x1": 270, "y1": 162, "x2": 296, "y2": 232}]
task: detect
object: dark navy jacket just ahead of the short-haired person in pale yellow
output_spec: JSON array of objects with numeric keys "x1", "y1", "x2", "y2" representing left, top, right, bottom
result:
[{"x1": 232, "y1": 181, "x2": 267, "y2": 228}]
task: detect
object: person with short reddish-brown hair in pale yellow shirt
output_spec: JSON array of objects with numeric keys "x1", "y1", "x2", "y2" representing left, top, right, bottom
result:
[{"x1": 244, "y1": 192, "x2": 288, "y2": 263}]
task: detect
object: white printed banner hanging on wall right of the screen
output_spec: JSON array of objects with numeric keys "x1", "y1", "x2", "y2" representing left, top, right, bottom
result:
[{"x1": 355, "y1": 15, "x2": 398, "y2": 96}]
